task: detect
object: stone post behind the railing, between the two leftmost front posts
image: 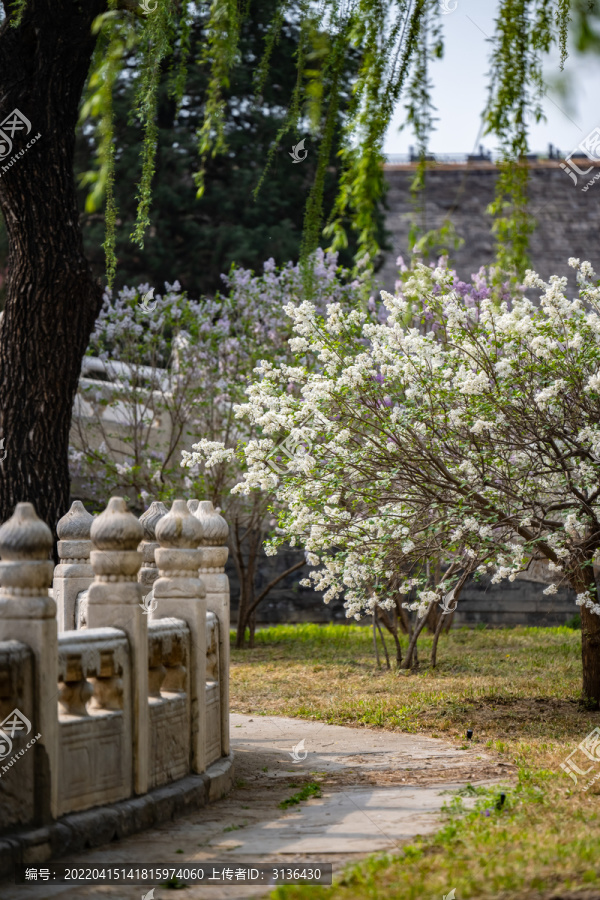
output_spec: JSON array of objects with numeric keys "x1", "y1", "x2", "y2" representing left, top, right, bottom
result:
[{"x1": 53, "y1": 500, "x2": 94, "y2": 631}]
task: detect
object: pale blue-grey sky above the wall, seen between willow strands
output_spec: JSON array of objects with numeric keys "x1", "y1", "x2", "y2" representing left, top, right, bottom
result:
[{"x1": 384, "y1": 0, "x2": 600, "y2": 155}]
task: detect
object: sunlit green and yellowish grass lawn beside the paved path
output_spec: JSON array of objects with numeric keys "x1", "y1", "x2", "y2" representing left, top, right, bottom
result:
[{"x1": 231, "y1": 625, "x2": 600, "y2": 900}]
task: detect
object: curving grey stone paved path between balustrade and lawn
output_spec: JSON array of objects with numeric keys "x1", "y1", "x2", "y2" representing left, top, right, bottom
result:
[{"x1": 0, "y1": 714, "x2": 514, "y2": 900}]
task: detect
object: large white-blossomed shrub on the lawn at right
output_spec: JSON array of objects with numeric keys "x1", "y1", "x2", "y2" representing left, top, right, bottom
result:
[{"x1": 224, "y1": 260, "x2": 600, "y2": 698}]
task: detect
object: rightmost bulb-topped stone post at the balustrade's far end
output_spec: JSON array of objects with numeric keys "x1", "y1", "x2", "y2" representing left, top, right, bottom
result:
[{"x1": 194, "y1": 500, "x2": 229, "y2": 756}]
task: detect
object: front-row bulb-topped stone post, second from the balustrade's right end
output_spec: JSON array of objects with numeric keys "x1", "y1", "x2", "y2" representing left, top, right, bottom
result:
[{"x1": 151, "y1": 500, "x2": 206, "y2": 773}]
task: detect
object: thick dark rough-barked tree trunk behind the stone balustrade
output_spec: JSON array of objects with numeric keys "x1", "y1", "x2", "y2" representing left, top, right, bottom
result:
[{"x1": 0, "y1": 0, "x2": 106, "y2": 532}]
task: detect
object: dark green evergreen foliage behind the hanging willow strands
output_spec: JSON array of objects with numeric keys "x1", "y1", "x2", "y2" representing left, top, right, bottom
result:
[{"x1": 76, "y1": 0, "x2": 384, "y2": 296}]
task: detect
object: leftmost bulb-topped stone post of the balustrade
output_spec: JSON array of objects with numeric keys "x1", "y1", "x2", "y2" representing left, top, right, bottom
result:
[{"x1": 0, "y1": 503, "x2": 58, "y2": 824}]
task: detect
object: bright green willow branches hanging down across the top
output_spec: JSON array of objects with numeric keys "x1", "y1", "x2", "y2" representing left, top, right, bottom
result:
[{"x1": 5, "y1": 0, "x2": 594, "y2": 283}]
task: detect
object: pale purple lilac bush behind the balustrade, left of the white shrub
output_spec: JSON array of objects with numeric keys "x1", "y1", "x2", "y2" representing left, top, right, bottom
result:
[{"x1": 71, "y1": 251, "x2": 363, "y2": 640}]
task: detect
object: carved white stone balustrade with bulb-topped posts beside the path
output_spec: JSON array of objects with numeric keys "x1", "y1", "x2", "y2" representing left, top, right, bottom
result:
[{"x1": 0, "y1": 497, "x2": 232, "y2": 873}]
